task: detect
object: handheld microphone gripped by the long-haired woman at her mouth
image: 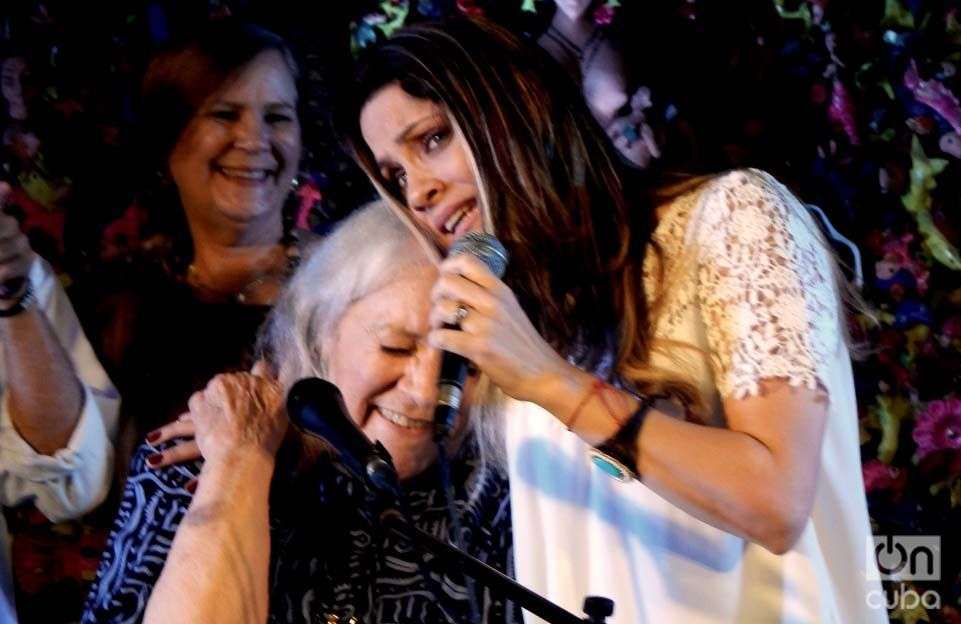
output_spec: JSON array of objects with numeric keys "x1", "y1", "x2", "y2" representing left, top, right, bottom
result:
[{"x1": 434, "y1": 232, "x2": 507, "y2": 442}]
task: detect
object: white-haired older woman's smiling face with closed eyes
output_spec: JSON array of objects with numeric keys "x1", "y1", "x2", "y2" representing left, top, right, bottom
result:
[{"x1": 326, "y1": 268, "x2": 473, "y2": 479}]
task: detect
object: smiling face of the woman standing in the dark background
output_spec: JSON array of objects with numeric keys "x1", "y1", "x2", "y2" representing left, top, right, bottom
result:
[{"x1": 169, "y1": 51, "x2": 301, "y2": 236}]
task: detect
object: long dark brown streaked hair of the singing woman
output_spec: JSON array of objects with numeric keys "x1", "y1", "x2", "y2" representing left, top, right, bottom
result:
[{"x1": 336, "y1": 18, "x2": 696, "y2": 403}]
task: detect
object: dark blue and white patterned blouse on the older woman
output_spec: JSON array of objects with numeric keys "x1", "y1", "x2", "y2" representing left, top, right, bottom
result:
[{"x1": 82, "y1": 444, "x2": 522, "y2": 624}]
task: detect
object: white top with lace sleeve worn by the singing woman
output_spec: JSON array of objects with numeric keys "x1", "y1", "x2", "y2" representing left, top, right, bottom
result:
[{"x1": 506, "y1": 170, "x2": 887, "y2": 624}]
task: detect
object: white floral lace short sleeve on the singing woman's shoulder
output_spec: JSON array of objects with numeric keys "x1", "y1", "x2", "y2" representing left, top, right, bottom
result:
[{"x1": 688, "y1": 170, "x2": 843, "y2": 399}]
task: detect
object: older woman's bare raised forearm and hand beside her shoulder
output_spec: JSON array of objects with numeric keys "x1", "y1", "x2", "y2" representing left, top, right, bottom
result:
[{"x1": 144, "y1": 360, "x2": 288, "y2": 623}]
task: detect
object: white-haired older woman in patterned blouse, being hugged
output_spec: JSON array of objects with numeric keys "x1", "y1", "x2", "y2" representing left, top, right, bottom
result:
[{"x1": 83, "y1": 204, "x2": 520, "y2": 624}]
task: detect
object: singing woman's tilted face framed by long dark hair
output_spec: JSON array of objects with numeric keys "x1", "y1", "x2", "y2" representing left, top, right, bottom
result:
[{"x1": 360, "y1": 83, "x2": 483, "y2": 249}]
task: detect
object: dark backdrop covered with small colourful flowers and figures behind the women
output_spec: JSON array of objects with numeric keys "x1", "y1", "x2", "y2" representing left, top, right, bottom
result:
[{"x1": 0, "y1": 0, "x2": 961, "y2": 624}]
